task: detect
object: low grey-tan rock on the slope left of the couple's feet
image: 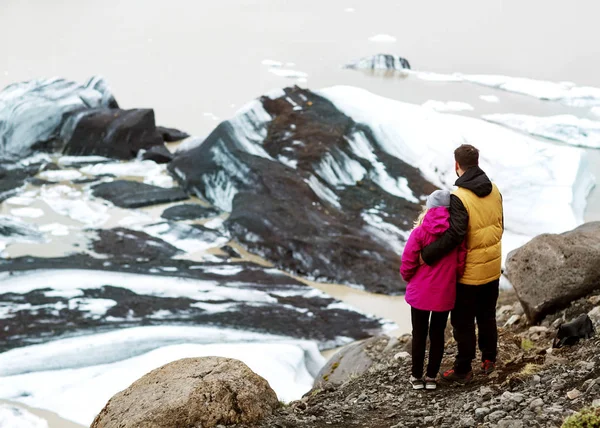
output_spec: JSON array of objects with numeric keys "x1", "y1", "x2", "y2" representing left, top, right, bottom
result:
[{"x1": 314, "y1": 335, "x2": 406, "y2": 388}]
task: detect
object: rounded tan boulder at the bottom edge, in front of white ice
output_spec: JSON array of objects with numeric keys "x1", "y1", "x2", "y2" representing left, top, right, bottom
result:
[{"x1": 91, "y1": 357, "x2": 279, "y2": 428}]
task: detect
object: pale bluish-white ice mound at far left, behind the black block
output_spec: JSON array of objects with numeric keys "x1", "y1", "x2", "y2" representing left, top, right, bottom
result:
[{"x1": 0, "y1": 77, "x2": 118, "y2": 159}]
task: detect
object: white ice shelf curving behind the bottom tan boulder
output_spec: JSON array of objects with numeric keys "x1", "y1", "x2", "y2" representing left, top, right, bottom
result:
[{"x1": 0, "y1": 327, "x2": 324, "y2": 426}]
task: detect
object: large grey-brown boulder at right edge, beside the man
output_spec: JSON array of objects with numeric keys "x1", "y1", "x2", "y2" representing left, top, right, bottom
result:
[{"x1": 505, "y1": 222, "x2": 600, "y2": 323}]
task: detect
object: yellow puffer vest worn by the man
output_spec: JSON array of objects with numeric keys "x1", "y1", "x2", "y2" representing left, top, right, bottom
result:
[{"x1": 453, "y1": 184, "x2": 503, "y2": 285}]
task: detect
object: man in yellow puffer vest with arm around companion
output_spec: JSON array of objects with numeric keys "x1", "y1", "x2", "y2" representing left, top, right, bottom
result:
[{"x1": 421, "y1": 144, "x2": 504, "y2": 384}]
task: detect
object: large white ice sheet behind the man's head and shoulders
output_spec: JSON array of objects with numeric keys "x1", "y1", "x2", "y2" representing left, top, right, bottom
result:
[{"x1": 320, "y1": 86, "x2": 594, "y2": 244}]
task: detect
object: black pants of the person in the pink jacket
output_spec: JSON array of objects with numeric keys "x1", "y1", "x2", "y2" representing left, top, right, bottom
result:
[{"x1": 410, "y1": 308, "x2": 449, "y2": 379}]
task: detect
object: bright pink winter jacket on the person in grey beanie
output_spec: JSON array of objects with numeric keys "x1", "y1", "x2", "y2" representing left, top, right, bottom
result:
[{"x1": 400, "y1": 207, "x2": 467, "y2": 312}]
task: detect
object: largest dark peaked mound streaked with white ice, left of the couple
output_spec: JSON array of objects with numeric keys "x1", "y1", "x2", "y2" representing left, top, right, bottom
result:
[{"x1": 169, "y1": 88, "x2": 435, "y2": 294}]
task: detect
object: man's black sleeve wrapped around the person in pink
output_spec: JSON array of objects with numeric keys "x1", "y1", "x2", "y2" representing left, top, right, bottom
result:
[{"x1": 421, "y1": 195, "x2": 469, "y2": 266}]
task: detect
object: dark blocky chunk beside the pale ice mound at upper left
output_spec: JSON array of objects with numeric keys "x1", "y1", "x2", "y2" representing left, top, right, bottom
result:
[{"x1": 61, "y1": 108, "x2": 164, "y2": 160}]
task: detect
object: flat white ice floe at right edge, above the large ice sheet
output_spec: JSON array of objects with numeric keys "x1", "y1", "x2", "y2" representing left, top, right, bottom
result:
[{"x1": 483, "y1": 113, "x2": 600, "y2": 149}]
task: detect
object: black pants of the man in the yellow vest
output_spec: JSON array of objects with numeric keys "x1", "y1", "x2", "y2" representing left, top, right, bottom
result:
[{"x1": 451, "y1": 280, "x2": 500, "y2": 374}]
